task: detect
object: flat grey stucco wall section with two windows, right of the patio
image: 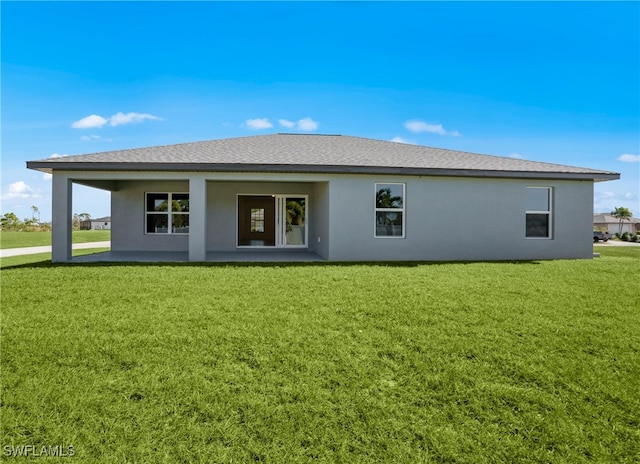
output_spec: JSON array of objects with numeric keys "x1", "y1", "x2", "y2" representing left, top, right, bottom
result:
[{"x1": 329, "y1": 176, "x2": 593, "y2": 261}]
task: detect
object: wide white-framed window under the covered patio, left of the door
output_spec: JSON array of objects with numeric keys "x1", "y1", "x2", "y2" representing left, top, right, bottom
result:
[{"x1": 145, "y1": 193, "x2": 189, "y2": 234}]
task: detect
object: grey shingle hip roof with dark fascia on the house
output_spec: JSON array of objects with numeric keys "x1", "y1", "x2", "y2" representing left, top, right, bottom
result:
[{"x1": 27, "y1": 134, "x2": 620, "y2": 180}]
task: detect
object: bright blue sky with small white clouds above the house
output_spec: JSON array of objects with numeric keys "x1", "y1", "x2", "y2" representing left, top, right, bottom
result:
[{"x1": 0, "y1": 1, "x2": 640, "y2": 220}]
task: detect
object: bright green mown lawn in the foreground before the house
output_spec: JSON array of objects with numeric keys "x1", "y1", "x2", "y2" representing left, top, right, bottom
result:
[{"x1": 0, "y1": 247, "x2": 640, "y2": 463}]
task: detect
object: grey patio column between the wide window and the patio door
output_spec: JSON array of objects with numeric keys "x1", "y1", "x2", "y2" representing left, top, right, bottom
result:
[{"x1": 189, "y1": 175, "x2": 207, "y2": 262}]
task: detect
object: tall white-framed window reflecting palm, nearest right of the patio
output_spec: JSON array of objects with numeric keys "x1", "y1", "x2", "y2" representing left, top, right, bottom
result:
[{"x1": 375, "y1": 184, "x2": 404, "y2": 238}]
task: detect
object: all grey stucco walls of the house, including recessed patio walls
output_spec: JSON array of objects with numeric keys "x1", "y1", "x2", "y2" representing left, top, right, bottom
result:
[{"x1": 91, "y1": 173, "x2": 593, "y2": 261}]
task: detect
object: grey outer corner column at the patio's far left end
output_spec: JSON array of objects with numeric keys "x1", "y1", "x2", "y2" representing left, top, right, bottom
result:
[{"x1": 51, "y1": 171, "x2": 73, "y2": 263}]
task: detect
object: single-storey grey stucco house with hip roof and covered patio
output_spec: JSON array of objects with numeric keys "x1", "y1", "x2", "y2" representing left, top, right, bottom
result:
[{"x1": 27, "y1": 134, "x2": 620, "y2": 262}]
